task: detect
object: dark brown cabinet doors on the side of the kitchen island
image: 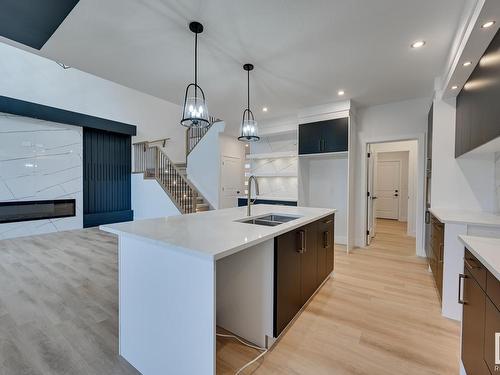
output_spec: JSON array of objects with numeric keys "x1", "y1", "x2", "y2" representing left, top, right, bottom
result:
[{"x1": 274, "y1": 215, "x2": 334, "y2": 337}]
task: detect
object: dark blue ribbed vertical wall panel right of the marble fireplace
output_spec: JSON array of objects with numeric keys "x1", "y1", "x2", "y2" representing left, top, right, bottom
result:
[{"x1": 83, "y1": 128, "x2": 133, "y2": 228}]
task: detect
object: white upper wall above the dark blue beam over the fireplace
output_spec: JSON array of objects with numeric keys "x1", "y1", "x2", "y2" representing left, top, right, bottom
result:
[{"x1": 0, "y1": 43, "x2": 185, "y2": 162}]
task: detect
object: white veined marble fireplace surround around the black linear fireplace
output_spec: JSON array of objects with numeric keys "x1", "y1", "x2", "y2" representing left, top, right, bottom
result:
[{"x1": 0, "y1": 113, "x2": 83, "y2": 239}]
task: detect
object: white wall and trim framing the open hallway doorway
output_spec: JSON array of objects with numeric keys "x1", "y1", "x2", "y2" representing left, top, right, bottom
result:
[{"x1": 354, "y1": 98, "x2": 431, "y2": 256}]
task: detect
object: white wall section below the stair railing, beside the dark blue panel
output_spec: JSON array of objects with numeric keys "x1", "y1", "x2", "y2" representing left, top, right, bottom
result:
[{"x1": 131, "y1": 173, "x2": 181, "y2": 220}]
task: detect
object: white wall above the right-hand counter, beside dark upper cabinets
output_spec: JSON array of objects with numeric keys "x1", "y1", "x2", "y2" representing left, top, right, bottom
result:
[{"x1": 431, "y1": 99, "x2": 498, "y2": 212}]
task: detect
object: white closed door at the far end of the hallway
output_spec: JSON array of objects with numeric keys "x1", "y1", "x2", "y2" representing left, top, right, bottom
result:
[{"x1": 376, "y1": 161, "x2": 401, "y2": 220}]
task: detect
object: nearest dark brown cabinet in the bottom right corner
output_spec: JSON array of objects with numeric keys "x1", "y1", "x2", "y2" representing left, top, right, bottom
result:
[{"x1": 459, "y1": 249, "x2": 500, "y2": 375}]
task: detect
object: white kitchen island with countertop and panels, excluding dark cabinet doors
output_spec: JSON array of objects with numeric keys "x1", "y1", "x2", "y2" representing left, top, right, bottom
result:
[{"x1": 101, "y1": 205, "x2": 335, "y2": 375}]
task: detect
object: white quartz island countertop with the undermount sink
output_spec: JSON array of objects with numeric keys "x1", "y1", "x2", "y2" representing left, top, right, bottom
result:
[{"x1": 100, "y1": 204, "x2": 336, "y2": 260}]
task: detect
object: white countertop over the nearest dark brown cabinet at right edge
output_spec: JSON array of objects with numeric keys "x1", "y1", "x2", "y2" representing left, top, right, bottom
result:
[{"x1": 458, "y1": 236, "x2": 500, "y2": 280}]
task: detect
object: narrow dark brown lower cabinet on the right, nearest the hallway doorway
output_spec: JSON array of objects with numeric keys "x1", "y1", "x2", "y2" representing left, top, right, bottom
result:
[{"x1": 427, "y1": 215, "x2": 444, "y2": 298}]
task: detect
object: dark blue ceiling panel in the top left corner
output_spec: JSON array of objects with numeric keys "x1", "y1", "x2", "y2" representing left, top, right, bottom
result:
[{"x1": 0, "y1": 0, "x2": 79, "y2": 49}]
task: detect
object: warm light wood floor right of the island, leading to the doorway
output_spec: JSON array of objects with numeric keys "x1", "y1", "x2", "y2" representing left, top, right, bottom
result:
[{"x1": 217, "y1": 220, "x2": 460, "y2": 375}]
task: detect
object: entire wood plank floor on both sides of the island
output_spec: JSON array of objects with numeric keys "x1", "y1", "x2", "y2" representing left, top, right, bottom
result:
[{"x1": 0, "y1": 221, "x2": 459, "y2": 375}]
